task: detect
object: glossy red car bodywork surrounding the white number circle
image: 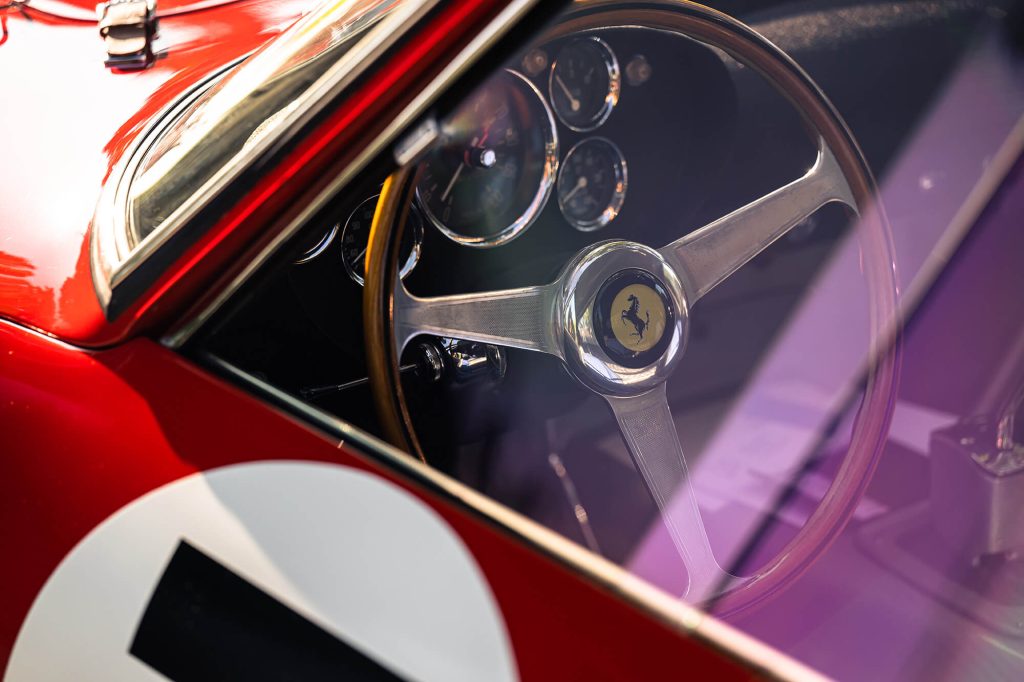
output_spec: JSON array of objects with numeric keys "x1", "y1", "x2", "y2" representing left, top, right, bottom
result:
[{"x1": 0, "y1": 0, "x2": 800, "y2": 679}]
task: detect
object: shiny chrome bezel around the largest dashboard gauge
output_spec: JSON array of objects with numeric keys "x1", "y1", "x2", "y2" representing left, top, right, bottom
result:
[{"x1": 416, "y1": 69, "x2": 558, "y2": 249}]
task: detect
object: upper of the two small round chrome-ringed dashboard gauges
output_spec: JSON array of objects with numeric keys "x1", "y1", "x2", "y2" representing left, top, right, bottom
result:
[{"x1": 548, "y1": 38, "x2": 622, "y2": 131}]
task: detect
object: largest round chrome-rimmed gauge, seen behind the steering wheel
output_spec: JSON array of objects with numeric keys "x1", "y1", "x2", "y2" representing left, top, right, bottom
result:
[{"x1": 417, "y1": 71, "x2": 558, "y2": 248}]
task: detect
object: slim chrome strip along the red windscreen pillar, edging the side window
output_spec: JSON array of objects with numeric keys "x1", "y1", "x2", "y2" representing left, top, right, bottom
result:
[{"x1": 162, "y1": 0, "x2": 552, "y2": 348}]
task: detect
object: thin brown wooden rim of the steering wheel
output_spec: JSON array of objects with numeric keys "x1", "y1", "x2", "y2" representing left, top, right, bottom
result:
[{"x1": 364, "y1": 0, "x2": 900, "y2": 614}]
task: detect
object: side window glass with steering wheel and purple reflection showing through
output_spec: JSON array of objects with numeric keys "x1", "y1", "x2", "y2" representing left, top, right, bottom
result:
[{"x1": 203, "y1": 0, "x2": 1024, "y2": 681}]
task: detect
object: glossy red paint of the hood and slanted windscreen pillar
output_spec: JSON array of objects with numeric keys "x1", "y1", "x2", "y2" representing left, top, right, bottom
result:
[{"x1": 0, "y1": 0, "x2": 540, "y2": 347}]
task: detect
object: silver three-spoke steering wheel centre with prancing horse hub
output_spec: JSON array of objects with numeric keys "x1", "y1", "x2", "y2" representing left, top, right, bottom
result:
[{"x1": 392, "y1": 141, "x2": 858, "y2": 603}]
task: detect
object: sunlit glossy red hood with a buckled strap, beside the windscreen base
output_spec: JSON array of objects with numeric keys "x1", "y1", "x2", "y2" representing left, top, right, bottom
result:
[{"x1": 0, "y1": 0, "x2": 308, "y2": 344}]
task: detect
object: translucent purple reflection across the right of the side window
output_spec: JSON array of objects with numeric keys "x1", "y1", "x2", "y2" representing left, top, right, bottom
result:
[{"x1": 630, "y1": 21, "x2": 1024, "y2": 680}]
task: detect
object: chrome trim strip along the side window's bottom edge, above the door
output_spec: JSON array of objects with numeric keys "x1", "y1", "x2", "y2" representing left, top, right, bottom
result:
[{"x1": 205, "y1": 354, "x2": 827, "y2": 681}]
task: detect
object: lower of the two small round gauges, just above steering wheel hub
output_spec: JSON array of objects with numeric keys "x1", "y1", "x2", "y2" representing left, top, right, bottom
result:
[{"x1": 558, "y1": 137, "x2": 627, "y2": 232}]
